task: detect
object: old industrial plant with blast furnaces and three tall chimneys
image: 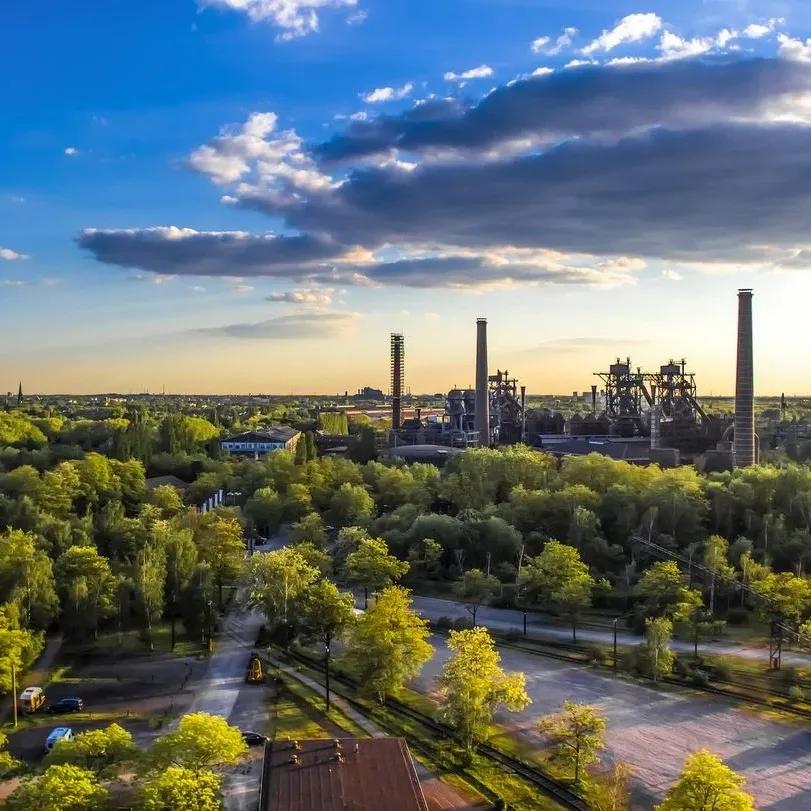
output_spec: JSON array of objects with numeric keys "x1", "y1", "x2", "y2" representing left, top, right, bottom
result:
[{"x1": 390, "y1": 289, "x2": 758, "y2": 470}]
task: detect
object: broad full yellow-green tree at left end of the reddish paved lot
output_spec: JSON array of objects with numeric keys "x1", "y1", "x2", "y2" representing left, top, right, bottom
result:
[{"x1": 343, "y1": 586, "x2": 434, "y2": 703}]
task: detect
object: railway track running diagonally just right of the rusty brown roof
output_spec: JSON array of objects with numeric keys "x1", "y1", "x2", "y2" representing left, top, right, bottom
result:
[{"x1": 276, "y1": 651, "x2": 589, "y2": 811}]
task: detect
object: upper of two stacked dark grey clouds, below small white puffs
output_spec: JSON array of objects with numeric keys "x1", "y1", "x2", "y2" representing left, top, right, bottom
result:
[{"x1": 314, "y1": 59, "x2": 811, "y2": 162}]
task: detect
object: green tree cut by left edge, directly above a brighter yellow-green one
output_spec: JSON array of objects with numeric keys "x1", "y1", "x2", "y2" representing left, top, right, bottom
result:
[{"x1": 0, "y1": 529, "x2": 59, "y2": 630}]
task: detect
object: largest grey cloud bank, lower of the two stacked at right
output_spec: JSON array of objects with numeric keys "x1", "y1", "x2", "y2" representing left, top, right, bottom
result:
[{"x1": 290, "y1": 124, "x2": 811, "y2": 261}]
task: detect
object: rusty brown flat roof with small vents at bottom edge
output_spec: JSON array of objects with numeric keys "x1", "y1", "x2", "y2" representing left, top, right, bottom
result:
[{"x1": 259, "y1": 738, "x2": 428, "y2": 811}]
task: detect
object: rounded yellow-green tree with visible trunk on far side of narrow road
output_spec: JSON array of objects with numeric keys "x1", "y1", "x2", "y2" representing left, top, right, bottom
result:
[{"x1": 519, "y1": 541, "x2": 598, "y2": 641}]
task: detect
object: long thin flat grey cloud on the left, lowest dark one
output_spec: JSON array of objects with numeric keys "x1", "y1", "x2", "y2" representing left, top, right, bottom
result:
[{"x1": 78, "y1": 227, "x2": 339, "y2": 276}]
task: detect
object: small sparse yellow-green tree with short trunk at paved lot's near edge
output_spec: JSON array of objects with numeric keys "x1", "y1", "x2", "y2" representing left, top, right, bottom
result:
[{"x1": 538, "y1": 701, "x2": 605, "y2": 783}]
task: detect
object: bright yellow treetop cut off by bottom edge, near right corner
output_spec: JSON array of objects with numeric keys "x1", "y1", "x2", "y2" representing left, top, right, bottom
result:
[{"x1": 656, "y1": 749, "x2": 755, "y2": 811}]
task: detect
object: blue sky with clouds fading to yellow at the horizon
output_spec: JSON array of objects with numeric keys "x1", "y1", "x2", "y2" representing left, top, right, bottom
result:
[{"x1": 0, "y1": 0, "x2": 811, "y2": 395}]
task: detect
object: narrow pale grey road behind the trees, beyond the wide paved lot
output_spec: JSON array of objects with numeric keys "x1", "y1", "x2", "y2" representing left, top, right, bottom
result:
[{"x1": 412, "y1": 595, "x2": 811, "y2": 666}]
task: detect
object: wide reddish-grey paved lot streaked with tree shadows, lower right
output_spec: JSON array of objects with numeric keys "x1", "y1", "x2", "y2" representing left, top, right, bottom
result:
[{"x1": 416, "y1": 636, "x2": 811, "y2": 811}]
